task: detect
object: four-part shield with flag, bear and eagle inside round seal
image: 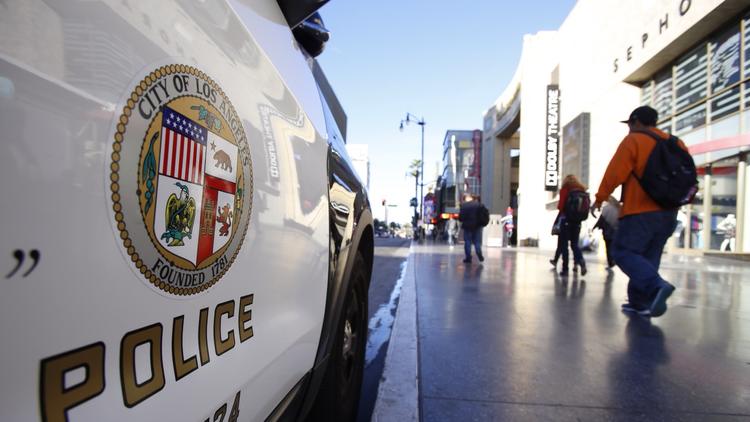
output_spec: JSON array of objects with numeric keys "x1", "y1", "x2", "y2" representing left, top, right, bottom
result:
[{"x1": 153, "y1": 106, "x2": 239, "y2": 265}]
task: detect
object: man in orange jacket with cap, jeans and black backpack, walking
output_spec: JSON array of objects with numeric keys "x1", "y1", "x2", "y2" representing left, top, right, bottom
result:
[{"x1": 594, "y1": 106, "x2": 697, "y2": 317}]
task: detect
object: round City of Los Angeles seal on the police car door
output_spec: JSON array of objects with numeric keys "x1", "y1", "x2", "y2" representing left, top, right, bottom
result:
[{"x1": 109, "y1": 64, "x2": 253, "y2": 296}]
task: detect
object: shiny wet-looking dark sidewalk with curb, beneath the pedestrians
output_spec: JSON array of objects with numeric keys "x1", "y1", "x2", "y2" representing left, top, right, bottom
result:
[{"x1": 373, "y1": 244, "x2": 750, "y2": 421}]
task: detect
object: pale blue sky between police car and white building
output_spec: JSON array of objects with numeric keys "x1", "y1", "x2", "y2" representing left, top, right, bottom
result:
[{"x1": 318, "y1": 0, "x2": 575, "y2": 224}]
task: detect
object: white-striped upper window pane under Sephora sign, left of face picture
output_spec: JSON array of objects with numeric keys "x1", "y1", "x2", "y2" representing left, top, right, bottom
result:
[{"x1": 674, "y1": 44, "x2": 708, "y2": 111}]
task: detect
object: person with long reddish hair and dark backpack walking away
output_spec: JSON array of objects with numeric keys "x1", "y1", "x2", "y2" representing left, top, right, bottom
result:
[{"x1": 557, "y1": 174, "x2": 590, "y2": 276}]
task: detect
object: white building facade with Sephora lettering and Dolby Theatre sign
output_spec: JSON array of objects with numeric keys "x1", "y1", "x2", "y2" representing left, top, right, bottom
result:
[{"x1": 482, "y1": 0, "x2": 750, "y2": 253}]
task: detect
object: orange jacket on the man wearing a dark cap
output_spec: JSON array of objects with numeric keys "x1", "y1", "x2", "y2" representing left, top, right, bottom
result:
[{"x1": 596, "y1": 128, "x2": 687, "y2": 217}]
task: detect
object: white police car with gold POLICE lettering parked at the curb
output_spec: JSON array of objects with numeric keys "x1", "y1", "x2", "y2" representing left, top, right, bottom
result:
[{"x1": 0, "y1": 0, "x2": 373, "y2": 422}]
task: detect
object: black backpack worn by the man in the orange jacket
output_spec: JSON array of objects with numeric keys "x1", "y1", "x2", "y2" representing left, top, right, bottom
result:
[{"x1": 633, "y1": 131, "x2": 698, "y2": 209}]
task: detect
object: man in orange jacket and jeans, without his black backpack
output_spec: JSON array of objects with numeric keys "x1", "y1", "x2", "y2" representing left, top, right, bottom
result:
[{"x1": 593, "y1": 106, "x2": 687, "y2": 317}]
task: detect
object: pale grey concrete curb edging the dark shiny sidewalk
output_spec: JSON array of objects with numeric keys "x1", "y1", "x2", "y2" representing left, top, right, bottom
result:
[{"x1": 371, "y1": 246, "x2": 419, "y2": 422}]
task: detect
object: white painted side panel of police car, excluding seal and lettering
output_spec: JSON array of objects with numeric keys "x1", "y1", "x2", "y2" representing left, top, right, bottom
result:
[{"x1": 0, "y1": 0, "x2": 356, "y2": 421}]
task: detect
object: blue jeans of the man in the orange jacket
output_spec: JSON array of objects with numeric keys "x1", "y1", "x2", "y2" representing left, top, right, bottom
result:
[{"x1": 612, "y1": 211, "x2": 677, "y2": 305}]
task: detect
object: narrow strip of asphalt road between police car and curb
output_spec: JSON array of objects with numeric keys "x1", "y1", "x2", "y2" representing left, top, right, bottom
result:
[{"x1": 357, "y1": 238, "x2": 411, "y2": 422}]
